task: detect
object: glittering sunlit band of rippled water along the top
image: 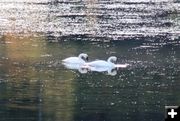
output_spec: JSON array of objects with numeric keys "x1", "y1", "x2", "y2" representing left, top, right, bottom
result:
[{"x1": 0, "y1": 0, "x2": 180, "y2": 39}]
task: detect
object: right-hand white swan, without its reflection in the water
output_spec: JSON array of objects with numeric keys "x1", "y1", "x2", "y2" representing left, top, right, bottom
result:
[{"x1": 84, "y1": 56, "x2": 117, "y2": 68}]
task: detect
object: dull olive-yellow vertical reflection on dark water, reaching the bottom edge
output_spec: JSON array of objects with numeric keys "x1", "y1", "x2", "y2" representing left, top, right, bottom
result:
[{"x1": 43, "y1": 71, "x2": 75, "y2": 121}]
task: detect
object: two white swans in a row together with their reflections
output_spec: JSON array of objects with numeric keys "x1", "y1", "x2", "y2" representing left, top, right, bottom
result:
[{"x1": 62, "y1": 53, "x2": 128, "y2": 75}]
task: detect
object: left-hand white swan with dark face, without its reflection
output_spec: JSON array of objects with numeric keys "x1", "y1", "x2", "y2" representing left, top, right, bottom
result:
[{"x1": 62, "y1": 53, "x2": 88, "y2": 64}]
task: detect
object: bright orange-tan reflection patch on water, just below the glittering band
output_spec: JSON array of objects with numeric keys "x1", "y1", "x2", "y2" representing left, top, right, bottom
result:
[{"x1": 2, "y1": 34, "x2": 45, "y2": 61}]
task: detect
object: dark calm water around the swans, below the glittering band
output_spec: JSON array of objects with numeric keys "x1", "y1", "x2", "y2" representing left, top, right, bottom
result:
[{"x1": 0, "y1": 34, "x2": 180, "y2": 121}]
